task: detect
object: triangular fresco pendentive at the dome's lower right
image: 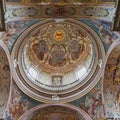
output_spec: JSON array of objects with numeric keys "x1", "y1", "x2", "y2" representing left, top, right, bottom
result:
[{"x1": 70, "y1": 79, "x2": 105, "y2": 120}]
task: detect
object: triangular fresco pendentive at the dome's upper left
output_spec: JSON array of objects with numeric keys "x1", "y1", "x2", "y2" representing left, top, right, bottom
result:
[{"x1": 1, "y1": 20, "x2": 37, "y2": 52}]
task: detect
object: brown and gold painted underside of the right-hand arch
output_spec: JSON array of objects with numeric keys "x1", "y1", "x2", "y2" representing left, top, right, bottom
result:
[{"x1": 103, "y1": 40, "x2": 120, "y2": 118}]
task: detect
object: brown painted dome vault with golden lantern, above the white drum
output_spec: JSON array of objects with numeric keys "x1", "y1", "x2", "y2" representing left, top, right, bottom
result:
[{"x1": 26, "y1": 22, "x2": 93, "y2": 74}]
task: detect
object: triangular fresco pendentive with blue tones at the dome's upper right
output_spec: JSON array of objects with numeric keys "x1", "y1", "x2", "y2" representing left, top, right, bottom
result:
[{"x1": 81, "y1": 19, "x2": 120, "y2": 52}]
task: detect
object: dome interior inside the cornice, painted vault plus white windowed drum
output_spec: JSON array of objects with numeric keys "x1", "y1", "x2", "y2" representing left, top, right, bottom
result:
[{"x1": 22, "y1": 19, "x2": 95, "y2": 90}]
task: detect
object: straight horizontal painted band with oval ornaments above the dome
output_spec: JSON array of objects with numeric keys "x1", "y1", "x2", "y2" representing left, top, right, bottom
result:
[{"x1": 6, "y1": 4, "x2": 115, "y2": 22}]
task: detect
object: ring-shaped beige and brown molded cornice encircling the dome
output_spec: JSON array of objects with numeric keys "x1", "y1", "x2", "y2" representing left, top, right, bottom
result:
[{"x1": 11, "y1": 19, "x2": 105, "y2": 103}]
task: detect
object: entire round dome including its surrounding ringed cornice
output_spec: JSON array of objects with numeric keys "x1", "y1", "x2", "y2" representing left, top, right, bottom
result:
[{"x1": 12, "y1": 19, "x2": 104, "y2": 102}]
